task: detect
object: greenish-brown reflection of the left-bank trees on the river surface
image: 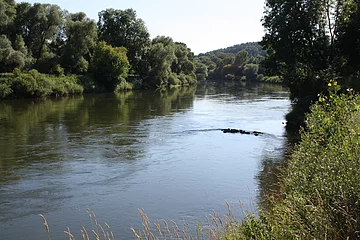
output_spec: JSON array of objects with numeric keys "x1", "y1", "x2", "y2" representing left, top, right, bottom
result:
[{"x1": 0, "y1": 87, "x2": 196, "y2": 183}]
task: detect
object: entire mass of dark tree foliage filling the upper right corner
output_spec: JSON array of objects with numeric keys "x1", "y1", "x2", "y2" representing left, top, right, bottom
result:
[{"x1": 261, "y1": 0, "x2": 360, "y2": 100}]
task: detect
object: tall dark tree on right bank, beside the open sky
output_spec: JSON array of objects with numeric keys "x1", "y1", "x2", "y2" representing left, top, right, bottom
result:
[{"x1": 261, "y1": 0, "x2": 330, "y2": 98}]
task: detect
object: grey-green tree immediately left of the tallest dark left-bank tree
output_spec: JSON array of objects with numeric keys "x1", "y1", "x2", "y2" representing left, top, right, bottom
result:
[{"x1": 61, "y1": 12, "x2": 97, "y2": 73}]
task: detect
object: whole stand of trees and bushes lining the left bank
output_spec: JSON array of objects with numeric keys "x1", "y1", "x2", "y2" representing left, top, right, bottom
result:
[{"x1": 0, "y1": 0, "x2": 207, "y2": 98}]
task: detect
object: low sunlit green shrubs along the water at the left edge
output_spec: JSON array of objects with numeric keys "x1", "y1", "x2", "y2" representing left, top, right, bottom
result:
[{"x1": 0, "y1": 70, "x2": 84, "y2": 99}]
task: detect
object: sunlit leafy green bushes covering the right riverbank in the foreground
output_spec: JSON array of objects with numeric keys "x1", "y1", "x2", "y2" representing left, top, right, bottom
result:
[{"x1": 225, "y1": 82, "x2": 360, "y2": 239}]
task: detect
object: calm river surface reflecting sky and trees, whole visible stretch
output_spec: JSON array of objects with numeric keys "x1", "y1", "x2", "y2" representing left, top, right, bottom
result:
[{"x1": 0, "y1": 83, "x2": 290, "y2": 240}]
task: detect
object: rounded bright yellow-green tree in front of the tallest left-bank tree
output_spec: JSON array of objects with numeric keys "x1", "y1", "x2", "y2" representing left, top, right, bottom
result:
[{"x1": 90, "y1": 41, "x2": 130, "y2": 91}]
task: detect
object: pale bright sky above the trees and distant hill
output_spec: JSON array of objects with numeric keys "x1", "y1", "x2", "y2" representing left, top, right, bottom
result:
[{"x1": 22, "y1": 0, "x2": 265, "y2": 54}]
